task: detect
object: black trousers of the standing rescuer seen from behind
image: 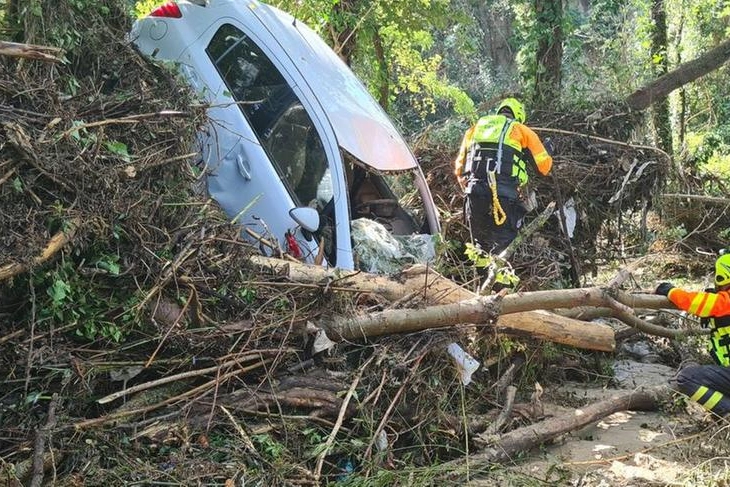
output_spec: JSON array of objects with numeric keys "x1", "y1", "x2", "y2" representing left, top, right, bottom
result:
[{"x1": 464, "y1": 184, "x2": 526, "y2": 254}]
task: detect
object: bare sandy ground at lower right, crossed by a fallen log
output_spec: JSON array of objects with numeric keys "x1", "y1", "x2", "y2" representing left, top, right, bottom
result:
[{"x1": 514, "y1": 360, "x2": 702, "y2": 487}]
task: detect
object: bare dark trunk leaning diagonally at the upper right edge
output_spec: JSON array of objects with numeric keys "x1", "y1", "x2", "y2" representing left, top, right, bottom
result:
[{"x1": 626, "y1": 39, "x2": 730, "y2": 111}]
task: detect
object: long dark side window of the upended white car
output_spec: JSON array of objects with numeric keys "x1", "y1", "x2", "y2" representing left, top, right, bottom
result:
[{"x1": 206, "y1": 24, "x2": 332, "y2": 206}]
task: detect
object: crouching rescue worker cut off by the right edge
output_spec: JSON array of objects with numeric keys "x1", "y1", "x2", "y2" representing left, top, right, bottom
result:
[{"x1": 655, "y1": 252, "x2": 730, "y2": 416}]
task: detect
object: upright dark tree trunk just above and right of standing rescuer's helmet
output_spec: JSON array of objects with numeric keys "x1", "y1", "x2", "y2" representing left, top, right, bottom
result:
[{"x1": 534, "y1": 0, "x2": 563, "y2": 103}]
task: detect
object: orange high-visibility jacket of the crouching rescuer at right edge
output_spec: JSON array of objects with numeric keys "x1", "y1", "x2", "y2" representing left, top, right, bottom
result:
[{"x1": 667, "y1": 287, "x2": 730, "y2": 367}]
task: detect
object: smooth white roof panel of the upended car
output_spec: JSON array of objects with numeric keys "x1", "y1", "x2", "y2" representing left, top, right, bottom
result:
[{"x1": 249, "y1": 2, "x2": 418, "y2": 171}]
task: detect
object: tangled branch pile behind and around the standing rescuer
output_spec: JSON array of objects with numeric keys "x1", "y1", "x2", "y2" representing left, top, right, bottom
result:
[{"x1": 417, "y1": 104, "x2": 670, "y2": 290}]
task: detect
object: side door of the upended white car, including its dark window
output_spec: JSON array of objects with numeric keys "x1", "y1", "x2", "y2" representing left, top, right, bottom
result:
[{"x1": 188, "y1": 18, "x2": 352, "y2": 267}]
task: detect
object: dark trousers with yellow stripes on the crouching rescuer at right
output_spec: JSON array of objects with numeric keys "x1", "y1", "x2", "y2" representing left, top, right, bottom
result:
[{"x1": 677, "y1": 365, "x2": 730, "y2": 416}]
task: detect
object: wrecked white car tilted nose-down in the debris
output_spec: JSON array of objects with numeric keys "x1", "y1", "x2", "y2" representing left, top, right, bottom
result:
[{"x1": 130, "y1": 0, "x2": 439, "y2": 269}]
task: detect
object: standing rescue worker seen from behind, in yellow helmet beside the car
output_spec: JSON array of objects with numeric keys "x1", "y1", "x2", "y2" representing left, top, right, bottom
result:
[{"x1": 454, "y1": 98, "x2": 553, "y2": 254}]
